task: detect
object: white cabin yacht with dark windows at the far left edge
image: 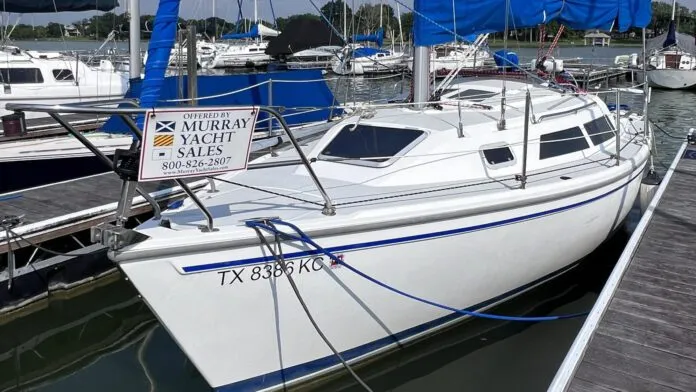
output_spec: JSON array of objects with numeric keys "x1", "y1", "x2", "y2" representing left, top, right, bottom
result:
[{"x1": 0, "y1": 46, "x2": 128, "y2": 118}]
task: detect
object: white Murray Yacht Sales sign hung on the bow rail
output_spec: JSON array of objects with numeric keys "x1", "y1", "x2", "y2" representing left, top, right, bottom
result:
[{"x1": 138, "y1": 107, "x2": 259, "y2": 181}]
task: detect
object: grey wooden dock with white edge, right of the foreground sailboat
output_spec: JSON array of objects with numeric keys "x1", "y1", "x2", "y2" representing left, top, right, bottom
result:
[{"x1": 549, "y1": 132, "x2": 696, "y2": 392}]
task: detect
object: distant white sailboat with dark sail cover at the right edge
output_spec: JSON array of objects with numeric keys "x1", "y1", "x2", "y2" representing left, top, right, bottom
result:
[{"x1": 646, "y1": 0, "x2": 696, "y2": 89}]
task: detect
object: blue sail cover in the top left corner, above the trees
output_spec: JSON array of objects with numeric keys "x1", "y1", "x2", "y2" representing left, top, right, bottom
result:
[{"x1": 0, "y1": 0, "x2": 118, "y2": 14}]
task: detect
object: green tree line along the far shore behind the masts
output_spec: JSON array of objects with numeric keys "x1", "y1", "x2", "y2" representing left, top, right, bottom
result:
[{"x1": 3, "y1": 0, "x2": 696, "y2": 41}]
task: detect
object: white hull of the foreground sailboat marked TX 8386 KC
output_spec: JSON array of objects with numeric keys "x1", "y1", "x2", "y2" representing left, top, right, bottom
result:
[{"x1": 117, "y1": 161, "x2": 647, "y2": 390}]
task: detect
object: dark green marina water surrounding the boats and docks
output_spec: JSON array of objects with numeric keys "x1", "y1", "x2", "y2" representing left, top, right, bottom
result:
[{"x1": 0, "y1": 42, "x2": 696, "y2": 392}]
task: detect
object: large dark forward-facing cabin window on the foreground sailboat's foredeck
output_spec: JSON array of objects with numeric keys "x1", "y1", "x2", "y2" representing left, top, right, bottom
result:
[{"x1": 320, "y1": 124, "x2": 425, "y2": 167}]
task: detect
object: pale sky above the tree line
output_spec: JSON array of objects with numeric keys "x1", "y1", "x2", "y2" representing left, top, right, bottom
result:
[{"x1": 16, "y1": 0, "x2": 696, "y2": 25}]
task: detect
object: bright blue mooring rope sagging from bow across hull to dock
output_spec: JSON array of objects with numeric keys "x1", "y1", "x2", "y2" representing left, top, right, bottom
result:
[{"x1": 246, "y1": 219, "x2": 588, "y2": 322}]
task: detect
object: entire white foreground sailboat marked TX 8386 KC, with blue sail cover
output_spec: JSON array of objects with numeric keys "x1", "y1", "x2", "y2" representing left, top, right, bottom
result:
[{"x1": 47, "y1": 0, "x2": 651, "y2": 390}]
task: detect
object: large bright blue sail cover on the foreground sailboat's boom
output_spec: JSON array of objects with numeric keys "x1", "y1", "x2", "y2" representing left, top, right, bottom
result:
[{"x1": 413, "y1": 0, "x2": 652, "y2": 46}]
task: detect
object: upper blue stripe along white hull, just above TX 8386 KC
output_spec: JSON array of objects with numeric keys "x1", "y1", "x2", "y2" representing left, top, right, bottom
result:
[{"x1": 182, "y1": 171, "x2": 642, "y2": 273}]
